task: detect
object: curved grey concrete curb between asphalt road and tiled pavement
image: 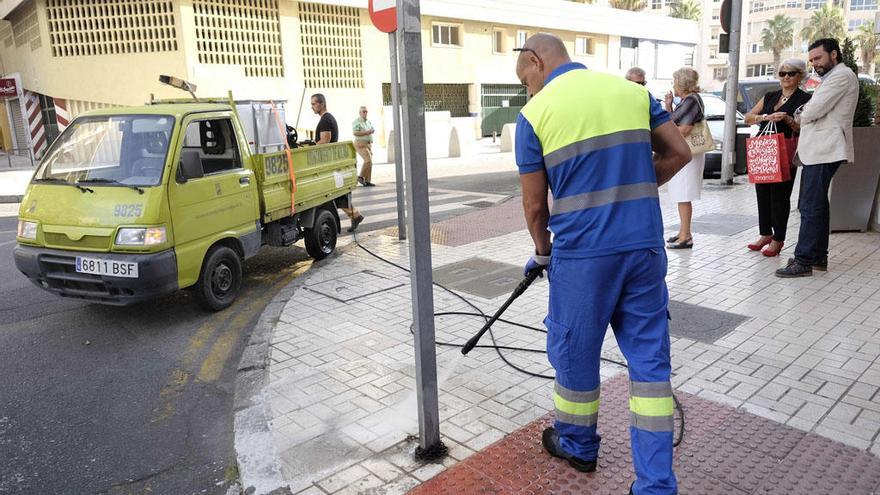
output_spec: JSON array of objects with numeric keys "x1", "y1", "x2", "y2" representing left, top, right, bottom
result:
[{"x1": 233, "y1": 242, "x2": 357, "y2": 495}]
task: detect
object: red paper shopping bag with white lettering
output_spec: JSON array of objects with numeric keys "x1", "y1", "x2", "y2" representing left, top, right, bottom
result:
[{"x1": 746, "y1": 122, "x2": 792, "y2": 184}]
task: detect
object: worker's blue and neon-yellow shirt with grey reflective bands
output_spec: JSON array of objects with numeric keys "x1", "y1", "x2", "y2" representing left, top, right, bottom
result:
[{"x1": 517, "y1": 64, "x2": 668, "y2": 257}]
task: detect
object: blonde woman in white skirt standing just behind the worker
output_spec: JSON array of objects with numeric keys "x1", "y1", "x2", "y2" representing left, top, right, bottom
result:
[{"x1": 664, "y1": 67, "x2": 706, "y2": 249}]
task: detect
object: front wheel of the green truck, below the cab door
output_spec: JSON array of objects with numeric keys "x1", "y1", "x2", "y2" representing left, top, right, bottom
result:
[{"x1": 195, "y1": 246, "x2": 241, "y2": 311}]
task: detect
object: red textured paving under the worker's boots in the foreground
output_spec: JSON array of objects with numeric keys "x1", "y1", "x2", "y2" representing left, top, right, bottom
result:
[{"x1": 410, "y1": 374, "x2": 880, "y2": 495}]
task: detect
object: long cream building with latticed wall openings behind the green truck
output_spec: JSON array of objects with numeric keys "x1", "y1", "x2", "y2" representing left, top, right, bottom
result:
[{"x1": 0, "y1": 0, "x2": 699, "y2": 157}]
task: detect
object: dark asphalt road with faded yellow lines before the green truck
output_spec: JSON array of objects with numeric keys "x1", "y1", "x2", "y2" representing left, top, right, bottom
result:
[{"x1": 0, "y1": 173, "x2": 519, "y2": 494}]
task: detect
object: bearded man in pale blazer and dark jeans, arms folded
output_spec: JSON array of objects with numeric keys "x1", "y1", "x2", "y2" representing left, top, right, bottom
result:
[{"x1": 776, "y1": 38, "x2": 859, "y2": 278}]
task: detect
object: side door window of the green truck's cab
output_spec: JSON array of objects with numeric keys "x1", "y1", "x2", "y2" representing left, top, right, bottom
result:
[{"x1": 180, "y1": 119, "x2": 241, "y2": 178}]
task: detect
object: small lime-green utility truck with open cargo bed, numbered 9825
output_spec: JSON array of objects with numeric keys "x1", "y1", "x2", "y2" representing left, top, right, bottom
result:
[{"x1": 14, "y1": 84, "x2": 357, "y2": 311}]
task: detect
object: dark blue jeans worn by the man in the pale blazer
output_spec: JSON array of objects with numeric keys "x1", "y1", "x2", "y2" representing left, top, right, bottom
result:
[{"x1": 794, "y1": 162, "x2": 843, "y2": 266}]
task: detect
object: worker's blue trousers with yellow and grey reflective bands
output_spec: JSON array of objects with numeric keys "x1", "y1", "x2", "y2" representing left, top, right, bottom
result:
[{"x1": 544, "y1": 248, "x2": 677, "y2": 495}]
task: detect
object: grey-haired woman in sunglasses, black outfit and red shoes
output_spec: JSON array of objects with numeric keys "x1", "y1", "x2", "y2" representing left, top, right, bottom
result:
[{"x1": 745, "y1": 58, "x2": 810, "y2": 256}]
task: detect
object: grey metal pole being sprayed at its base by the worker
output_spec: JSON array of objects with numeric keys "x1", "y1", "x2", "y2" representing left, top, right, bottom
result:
[{"x1": 397, "y1": 0, "x2": 443, "y2": 456}]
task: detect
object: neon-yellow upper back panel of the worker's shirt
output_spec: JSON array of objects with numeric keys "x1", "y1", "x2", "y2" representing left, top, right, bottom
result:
[{"x1": 522, "y1": 69, "x2": 651, "y2": 156}]
